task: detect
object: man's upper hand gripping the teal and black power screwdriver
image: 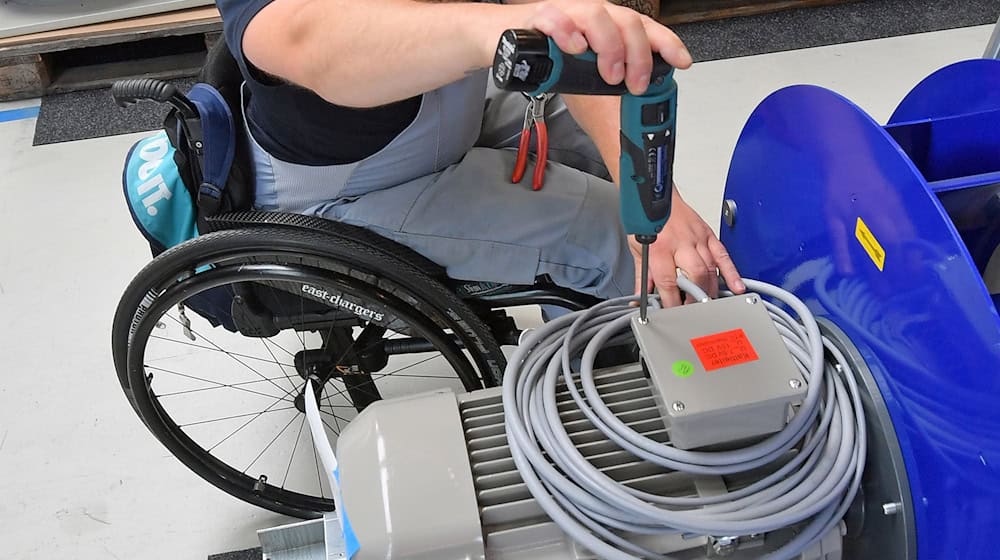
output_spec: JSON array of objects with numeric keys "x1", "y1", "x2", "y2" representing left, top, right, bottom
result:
[{"x1": 528, "y1": 0, "x2": 691, "y2": 95}]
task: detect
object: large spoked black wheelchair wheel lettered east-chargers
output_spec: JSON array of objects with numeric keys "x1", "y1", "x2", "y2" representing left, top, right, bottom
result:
[{"x1": 112, "y1": 227, "x2": 505, "y2": 517}]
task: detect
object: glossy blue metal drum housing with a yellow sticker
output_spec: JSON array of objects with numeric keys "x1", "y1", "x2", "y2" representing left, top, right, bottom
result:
[{"x1": 721, "y1": 60, "x2": 1000, "y2": 560}]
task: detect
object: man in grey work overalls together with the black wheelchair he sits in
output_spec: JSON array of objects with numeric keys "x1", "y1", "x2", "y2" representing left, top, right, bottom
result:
[{"x1": 112, "y1": 0, "x2": 743, "y2": 516}]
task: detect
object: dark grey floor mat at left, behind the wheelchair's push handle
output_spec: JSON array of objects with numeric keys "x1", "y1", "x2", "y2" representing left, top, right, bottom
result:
[{"x1": 33, "y1": 78, "x2": 194, "y2": 146}]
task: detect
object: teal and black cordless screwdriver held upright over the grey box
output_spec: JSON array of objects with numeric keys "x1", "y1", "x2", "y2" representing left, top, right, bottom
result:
[{"x1": 493, "y1": 29, "x2": 677, "y2": 322}]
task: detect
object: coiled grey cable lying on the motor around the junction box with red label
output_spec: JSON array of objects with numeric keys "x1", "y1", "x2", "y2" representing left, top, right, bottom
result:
[{"x1": 503, "y1": 276, "x2": 867, "y2": 560}]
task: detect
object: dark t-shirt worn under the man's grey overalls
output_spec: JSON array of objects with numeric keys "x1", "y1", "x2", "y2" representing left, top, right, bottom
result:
[{"x1": 216, "y1": 0, "x2": 420, "y2": 165}]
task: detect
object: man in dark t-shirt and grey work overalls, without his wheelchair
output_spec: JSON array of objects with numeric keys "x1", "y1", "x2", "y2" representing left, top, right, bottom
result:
[{"x1": 229, "y1": 0, "x2": 738, "y2": 303}]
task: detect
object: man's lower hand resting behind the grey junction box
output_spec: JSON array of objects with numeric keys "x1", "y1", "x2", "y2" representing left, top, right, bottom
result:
[{"x1": 629, "y1": 187, "x2": 746, "y2": 307}]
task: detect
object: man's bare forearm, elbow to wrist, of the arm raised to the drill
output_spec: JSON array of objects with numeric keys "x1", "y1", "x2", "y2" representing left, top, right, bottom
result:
[{"x1": 243, "y1": 0, "x2": 532, "y2": 107}]
